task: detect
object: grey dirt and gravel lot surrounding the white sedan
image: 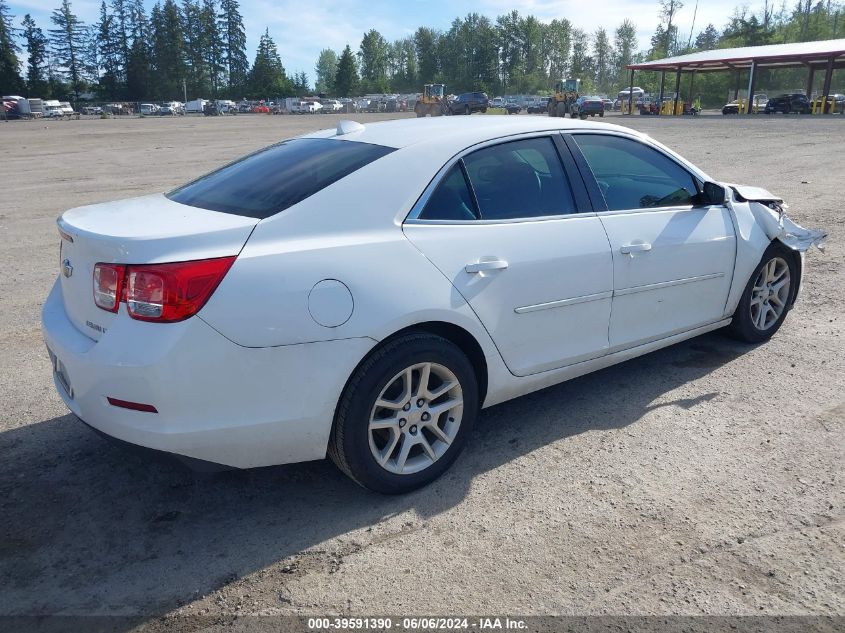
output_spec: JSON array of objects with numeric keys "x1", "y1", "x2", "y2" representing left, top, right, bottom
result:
[{"x1": 0, "y1": 110, "x2": 845, "y2": 626}]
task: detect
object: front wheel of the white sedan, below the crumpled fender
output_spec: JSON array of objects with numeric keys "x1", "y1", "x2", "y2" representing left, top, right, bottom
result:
[{"x1": 730, "y1": 242, "x2": 799, "y2": 343}]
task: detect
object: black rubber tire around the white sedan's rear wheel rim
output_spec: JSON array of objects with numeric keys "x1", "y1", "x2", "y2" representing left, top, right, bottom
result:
[{"x1": 328, "y1": 332, "x2": 479, "y2": 494}]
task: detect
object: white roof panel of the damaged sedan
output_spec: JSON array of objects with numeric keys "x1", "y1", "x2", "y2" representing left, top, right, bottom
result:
[{"x1": 304, "y1": 115, "x2": 642, "y2": 156}]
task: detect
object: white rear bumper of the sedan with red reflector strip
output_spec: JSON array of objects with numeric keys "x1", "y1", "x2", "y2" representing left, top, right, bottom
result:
[{"x1": 42, "y1": 283, "x2": 374, "y2": 468}]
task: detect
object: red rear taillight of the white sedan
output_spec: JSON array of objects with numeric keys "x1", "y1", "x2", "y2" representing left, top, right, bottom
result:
[{"x1": 94, "y1": 257, "x2": 235, "y2": 323}]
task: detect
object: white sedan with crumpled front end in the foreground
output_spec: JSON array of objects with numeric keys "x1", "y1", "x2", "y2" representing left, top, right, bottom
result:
[{"x1": 43, "y1": 117, "x2": 824, "y2": 493}]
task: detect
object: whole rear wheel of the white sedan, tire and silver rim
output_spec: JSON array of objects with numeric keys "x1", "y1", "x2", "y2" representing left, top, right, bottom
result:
[{"x1": 328, "y1": 332, "x2": 479, "y2": 494}]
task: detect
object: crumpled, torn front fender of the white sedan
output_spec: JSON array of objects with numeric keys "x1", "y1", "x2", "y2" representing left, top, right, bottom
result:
[{"x1": 727, "y1": 184, "x2": 827, "y2": 253}]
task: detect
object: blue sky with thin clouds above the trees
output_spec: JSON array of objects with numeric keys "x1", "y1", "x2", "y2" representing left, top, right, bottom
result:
[{"x1": 9, "y1": 0, "x2": 744, "y2": 82}]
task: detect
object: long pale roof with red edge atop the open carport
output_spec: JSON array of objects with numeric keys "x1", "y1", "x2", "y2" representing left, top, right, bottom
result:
[{"x1": 627, "y1": 39, "x2": 845, "y2": 72}]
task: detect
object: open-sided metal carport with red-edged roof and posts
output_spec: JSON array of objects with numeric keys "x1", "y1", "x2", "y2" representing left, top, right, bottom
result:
[{"x1": 626, "y1": 39, "x2": 845, "y2": 114}]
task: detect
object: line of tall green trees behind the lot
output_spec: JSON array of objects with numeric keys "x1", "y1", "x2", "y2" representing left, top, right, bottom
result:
[{"x1": 0, "y1": 0, "x2": 845, "y2": 101}]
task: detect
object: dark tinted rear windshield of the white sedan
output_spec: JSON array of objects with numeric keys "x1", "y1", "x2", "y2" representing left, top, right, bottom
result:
[{"x1": 167, "y1": 138, "x2": 395, "y2": 219}]
